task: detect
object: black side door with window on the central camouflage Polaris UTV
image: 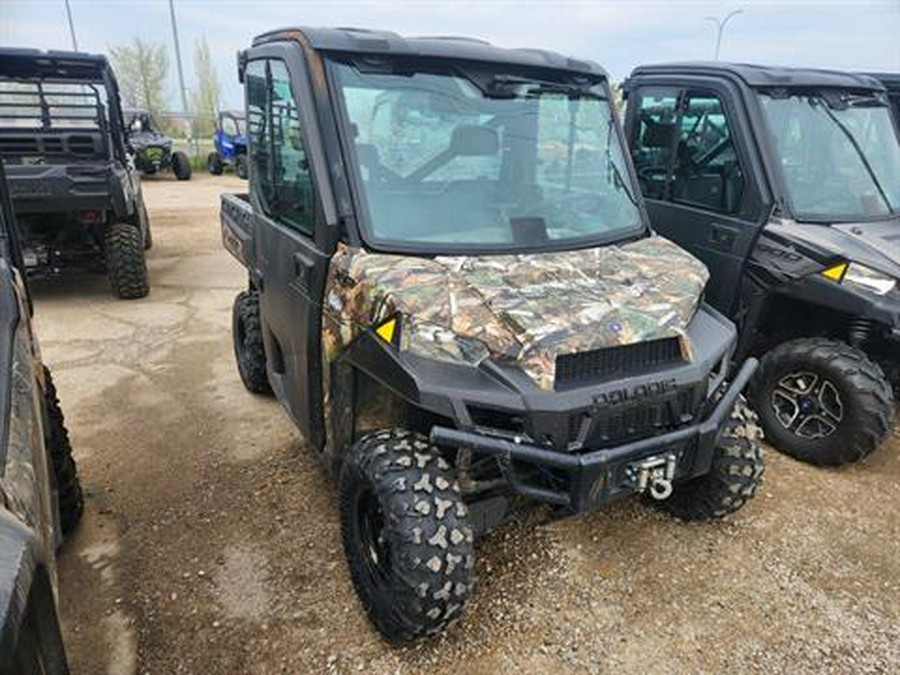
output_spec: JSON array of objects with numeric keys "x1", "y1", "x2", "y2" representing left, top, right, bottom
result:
[{"x1": 244, "y1": 51, "x2": 329, "y2": 447}]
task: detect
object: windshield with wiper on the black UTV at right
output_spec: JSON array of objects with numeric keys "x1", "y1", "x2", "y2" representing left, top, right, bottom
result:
[{"x1": 760, "y1": 91, "x2": 900, "y2": 222}]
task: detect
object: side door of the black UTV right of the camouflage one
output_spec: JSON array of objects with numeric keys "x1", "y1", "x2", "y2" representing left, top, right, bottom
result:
[{"x1": 626, "y1": 80, "x2": 767, "y2": 315}]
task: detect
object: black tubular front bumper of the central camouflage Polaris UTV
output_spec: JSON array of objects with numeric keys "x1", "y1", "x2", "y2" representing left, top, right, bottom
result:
[{"x1": 431, "y1": 359, "x2": 758, "y2": 512}]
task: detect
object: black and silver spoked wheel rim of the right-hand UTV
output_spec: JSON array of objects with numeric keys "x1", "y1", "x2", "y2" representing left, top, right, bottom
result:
[{"x1": 771, "y1": 371, "x2": 844, "y2": 440}]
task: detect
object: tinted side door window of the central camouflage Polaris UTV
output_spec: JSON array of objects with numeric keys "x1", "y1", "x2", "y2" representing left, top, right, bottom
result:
[{"x1": 244, "y1": 59, "x2": 316, "y2": 236}]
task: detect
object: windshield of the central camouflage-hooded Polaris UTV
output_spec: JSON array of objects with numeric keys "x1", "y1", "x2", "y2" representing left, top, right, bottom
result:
[{"x1": 335, "y1": 63, "x2": 643, "y2": 252}]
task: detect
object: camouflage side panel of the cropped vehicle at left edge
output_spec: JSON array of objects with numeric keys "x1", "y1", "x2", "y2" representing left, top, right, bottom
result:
[{"x1": 0, "y1": 286, "x2": 54, "y2": 573}]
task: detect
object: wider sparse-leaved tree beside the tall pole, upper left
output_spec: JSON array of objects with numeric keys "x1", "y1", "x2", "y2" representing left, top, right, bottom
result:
[{"x1": 109, "y1": 38, "x2": 169, "y2": 115}]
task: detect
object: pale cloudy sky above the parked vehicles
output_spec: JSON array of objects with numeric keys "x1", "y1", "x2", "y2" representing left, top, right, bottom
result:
[{"x1": 0, "y1": 0, "x2": 900, "y2": 107}]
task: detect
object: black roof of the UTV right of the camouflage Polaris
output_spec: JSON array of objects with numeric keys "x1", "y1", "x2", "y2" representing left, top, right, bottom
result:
[{"x1": 632, "y1": 61, "x2": 884, "y2": 91}]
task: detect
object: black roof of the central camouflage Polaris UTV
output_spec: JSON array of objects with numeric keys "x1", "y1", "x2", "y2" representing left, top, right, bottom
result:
[{"x1": 253, "y1": 28, "x2": 606, "y2": 77}]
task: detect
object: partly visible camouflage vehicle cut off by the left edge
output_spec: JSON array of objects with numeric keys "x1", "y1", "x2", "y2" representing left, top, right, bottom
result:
[{"x1": 0, "y1": 162, "x2": 84, "y2": 675}]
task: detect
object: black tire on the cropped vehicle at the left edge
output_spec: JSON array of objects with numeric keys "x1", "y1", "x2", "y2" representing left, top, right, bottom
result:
[{"x1": 44, "y1": 366, "x2": 84, "y2": 537}]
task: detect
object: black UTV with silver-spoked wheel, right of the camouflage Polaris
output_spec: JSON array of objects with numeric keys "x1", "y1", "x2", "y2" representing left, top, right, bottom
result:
[{"x1": 624, "y1": 63, "x2": 900, "y2": 464}]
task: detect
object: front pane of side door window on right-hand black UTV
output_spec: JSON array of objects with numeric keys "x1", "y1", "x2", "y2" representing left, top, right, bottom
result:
[{"x1": 671, "y1": 93, "x2": 744, "y2": 213}]
